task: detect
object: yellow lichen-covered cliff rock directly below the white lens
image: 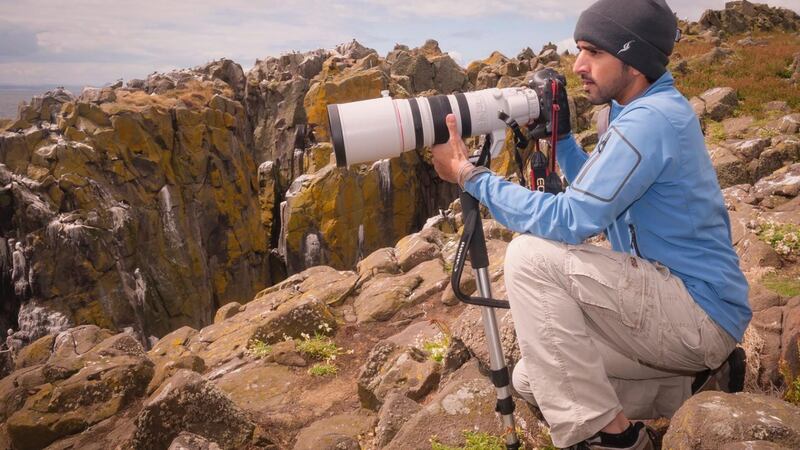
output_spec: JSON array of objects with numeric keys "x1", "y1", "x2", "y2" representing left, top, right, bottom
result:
[{"x1": 283, "y1": 154, "x2": 438, "y2": 274}]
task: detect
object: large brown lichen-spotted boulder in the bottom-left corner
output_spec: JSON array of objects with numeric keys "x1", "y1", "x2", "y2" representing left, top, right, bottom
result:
[{"x1": 7, "y1": 333, "x2": 153, "y2": 449}]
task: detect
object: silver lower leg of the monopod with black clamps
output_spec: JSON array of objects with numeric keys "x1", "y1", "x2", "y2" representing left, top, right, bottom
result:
[{"x1": 475, "y1": 267, "x2": 520, "y2": 449}]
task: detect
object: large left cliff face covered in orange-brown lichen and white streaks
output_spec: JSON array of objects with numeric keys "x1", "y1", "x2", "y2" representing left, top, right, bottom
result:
[{"x1": 0, "y1": 73, "x2": 271, "y2": 337}]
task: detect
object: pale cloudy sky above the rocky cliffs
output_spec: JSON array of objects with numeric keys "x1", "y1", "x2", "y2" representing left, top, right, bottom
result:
[{"x1": 0, "y1": 0, "x2": 800, "y2": 86}]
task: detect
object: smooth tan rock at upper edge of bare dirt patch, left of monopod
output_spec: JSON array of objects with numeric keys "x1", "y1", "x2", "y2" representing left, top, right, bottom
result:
[{"x1": 353, "y1": 274, "x2": 423, "y2": 323}]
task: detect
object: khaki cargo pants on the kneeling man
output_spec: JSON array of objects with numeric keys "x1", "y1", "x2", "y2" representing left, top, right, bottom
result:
[{"x1": 505, "y1": 235, "x2": 736, "y2": 447}]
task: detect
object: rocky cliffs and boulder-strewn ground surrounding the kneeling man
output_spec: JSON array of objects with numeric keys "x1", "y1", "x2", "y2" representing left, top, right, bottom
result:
[{"x1": 0, "y1": 2, "x2": 800, "y2": 449}]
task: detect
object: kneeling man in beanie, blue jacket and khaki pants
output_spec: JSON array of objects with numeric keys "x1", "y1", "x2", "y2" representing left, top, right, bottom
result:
[{"x1": 433, "y1": 0, "x2": 751, "y2": 449}]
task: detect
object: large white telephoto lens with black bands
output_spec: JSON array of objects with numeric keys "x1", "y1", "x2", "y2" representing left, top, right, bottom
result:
[{"x1": 328, "y1": 87, "x2": 541, "y2": 167}]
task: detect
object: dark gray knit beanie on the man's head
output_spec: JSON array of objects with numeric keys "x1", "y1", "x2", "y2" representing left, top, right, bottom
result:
[{"x1": 575, "y1": 0, "x2": 678, "y2": 80}]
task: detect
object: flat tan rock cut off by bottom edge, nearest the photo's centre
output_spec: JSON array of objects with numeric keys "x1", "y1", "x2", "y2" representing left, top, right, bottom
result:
[{"x1": 294, "y1": 413, "x2": 375, "y2": 450}]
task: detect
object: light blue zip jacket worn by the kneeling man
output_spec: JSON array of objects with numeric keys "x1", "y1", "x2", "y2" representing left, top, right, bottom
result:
[{"x1": 465, "y1": 72, "x2": 752, "y2": 341}]
